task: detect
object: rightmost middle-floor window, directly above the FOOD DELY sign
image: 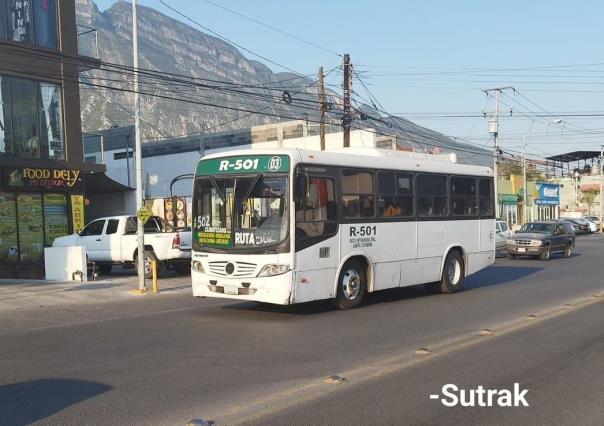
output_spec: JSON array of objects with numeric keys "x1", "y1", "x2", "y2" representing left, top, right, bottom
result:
[{"x1": 40, "y1": 83, "x2": 65, "y2": 160}]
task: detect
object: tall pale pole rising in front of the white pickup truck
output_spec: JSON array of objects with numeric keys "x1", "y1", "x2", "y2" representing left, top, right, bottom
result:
[{"x1": 132, "y1": 0, "x2": 146, "y2": 293}]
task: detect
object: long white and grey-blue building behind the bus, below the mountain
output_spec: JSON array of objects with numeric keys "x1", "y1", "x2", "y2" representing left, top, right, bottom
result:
[{"x1": 84, "y1": 120, "x2": 454, "y2": 226}]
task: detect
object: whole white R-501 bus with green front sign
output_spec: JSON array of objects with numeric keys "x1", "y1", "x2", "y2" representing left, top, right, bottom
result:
[{"x1": 192, "y1": 148, "x2": 495, "y2": 309}]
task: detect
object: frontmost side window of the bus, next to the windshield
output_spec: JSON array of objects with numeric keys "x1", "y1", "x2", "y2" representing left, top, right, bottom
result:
[{"x1": 296, "y1": 176, "x2": 337, "y2": 238}]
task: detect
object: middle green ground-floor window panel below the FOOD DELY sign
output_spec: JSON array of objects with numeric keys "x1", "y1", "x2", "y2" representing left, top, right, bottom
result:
[{"x1": 17, "y1": 194, "x2": 44, "y2": 266}]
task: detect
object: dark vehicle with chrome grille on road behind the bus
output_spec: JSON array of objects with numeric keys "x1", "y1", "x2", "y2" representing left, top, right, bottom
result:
[{"x1": 506, "y1": 221, "x2": 575, "y2": 260}]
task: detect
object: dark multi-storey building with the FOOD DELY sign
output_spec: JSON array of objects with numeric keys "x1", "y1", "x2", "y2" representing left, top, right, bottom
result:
[{"x1": 0, "y1": 0, "x2": 105, "y2": 278}]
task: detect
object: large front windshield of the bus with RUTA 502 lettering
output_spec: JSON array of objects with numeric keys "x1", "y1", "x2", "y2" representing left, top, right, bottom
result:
[{"x1": 193, "y1": 174, "x2": 289, "y2": 248}]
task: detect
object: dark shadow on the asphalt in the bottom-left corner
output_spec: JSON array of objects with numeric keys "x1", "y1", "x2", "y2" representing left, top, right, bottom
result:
[{"x1": 0, "y1": 379, "x2": 111, "y2": 425}]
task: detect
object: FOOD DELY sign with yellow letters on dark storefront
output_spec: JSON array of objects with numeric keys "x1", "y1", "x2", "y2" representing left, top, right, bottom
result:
[{"x1": 5, "y1": 167, "x2": 82, "y2": 190}]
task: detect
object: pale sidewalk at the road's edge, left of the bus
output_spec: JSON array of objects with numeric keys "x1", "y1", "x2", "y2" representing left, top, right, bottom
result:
[{"x1": 0, "y1": 269, "x2": 191, "y2": 312}]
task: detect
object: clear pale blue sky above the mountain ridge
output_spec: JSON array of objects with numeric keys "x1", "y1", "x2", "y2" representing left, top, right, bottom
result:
[{"x1": 96, "y1": 0, "x2": 604, "y2": 158}]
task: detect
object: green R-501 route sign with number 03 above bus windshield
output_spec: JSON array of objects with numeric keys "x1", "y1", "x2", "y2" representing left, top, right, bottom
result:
[{"x1": 196, "y1": 155, "x2": 289, "y2": 176}]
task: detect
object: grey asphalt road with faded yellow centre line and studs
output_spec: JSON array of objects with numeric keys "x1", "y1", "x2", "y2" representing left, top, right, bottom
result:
[{"x1": 0, "y1": 236, "x2": 604, "y2": 425}]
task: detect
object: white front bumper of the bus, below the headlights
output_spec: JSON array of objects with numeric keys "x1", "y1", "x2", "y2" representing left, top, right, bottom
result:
[{"x1": 191, "y1": 271, "x2": 293, "y2": 305}]
